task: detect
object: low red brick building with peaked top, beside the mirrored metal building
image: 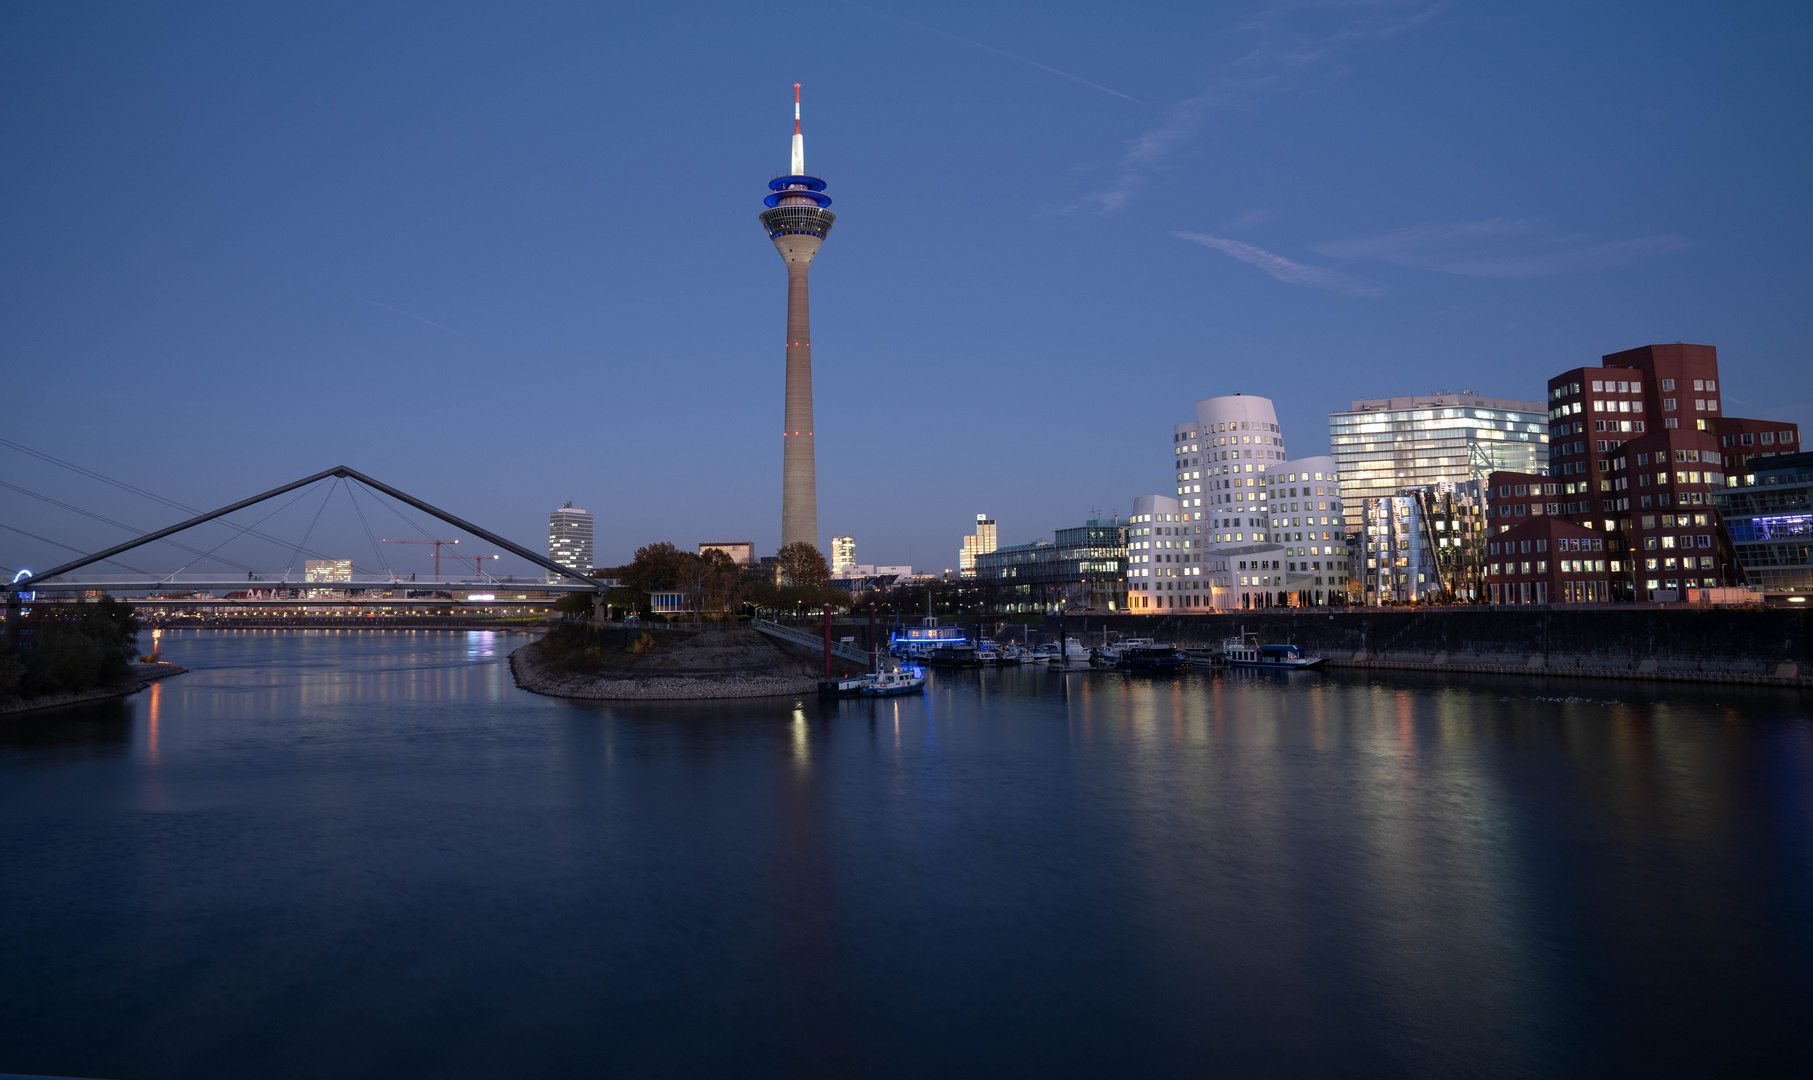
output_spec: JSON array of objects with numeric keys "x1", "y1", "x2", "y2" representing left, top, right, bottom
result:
[{"x1": 1485, "y1": 511, "x2": 1626, "y2": 603}]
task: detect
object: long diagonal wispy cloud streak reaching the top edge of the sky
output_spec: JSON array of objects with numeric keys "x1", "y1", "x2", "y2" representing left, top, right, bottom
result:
[{"x1": 1080, "y1": 0, "x2": 1443, "y2": 214}]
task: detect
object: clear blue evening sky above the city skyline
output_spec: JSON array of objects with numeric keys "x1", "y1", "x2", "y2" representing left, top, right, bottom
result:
[{"x1": 0, "y1": 0, "x2": 1813, "y2": 569}]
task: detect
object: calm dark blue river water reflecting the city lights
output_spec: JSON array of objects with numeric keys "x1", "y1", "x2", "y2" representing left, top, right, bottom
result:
[{"x1": 0, "y1": 631, "x2": 1813, "y2": 1080}]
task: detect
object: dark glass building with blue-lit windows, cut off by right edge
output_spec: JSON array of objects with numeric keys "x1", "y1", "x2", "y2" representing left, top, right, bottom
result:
[{"x1": 1711, "y1": 453, "x2": 1813, "y2": 602}]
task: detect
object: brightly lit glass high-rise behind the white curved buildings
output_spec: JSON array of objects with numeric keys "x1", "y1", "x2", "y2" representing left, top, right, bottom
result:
[{"x1": 1329, "y1": 390, "x2": 1548, "y2": 507}]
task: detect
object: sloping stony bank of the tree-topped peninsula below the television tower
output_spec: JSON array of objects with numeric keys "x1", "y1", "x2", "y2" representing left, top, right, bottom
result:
[{"x1": 509, "y1": 629, "x2": 818, "y2": 701}]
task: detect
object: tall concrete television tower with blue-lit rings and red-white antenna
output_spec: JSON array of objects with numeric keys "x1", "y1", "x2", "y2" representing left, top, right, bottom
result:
[{"x1": 761, "y1": 83, "x2": 838, "y2": 547}]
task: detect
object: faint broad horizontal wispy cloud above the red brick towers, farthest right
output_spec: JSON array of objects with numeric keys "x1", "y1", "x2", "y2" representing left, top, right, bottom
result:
[{"x1": 1314, "y1": 217, "x2": 1692, "y2": 277}]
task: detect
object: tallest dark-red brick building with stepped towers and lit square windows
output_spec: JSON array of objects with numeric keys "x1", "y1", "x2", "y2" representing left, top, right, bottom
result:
[{"x1": 1544, "y1": 344, "x2": 1800, "y2": 600}]
